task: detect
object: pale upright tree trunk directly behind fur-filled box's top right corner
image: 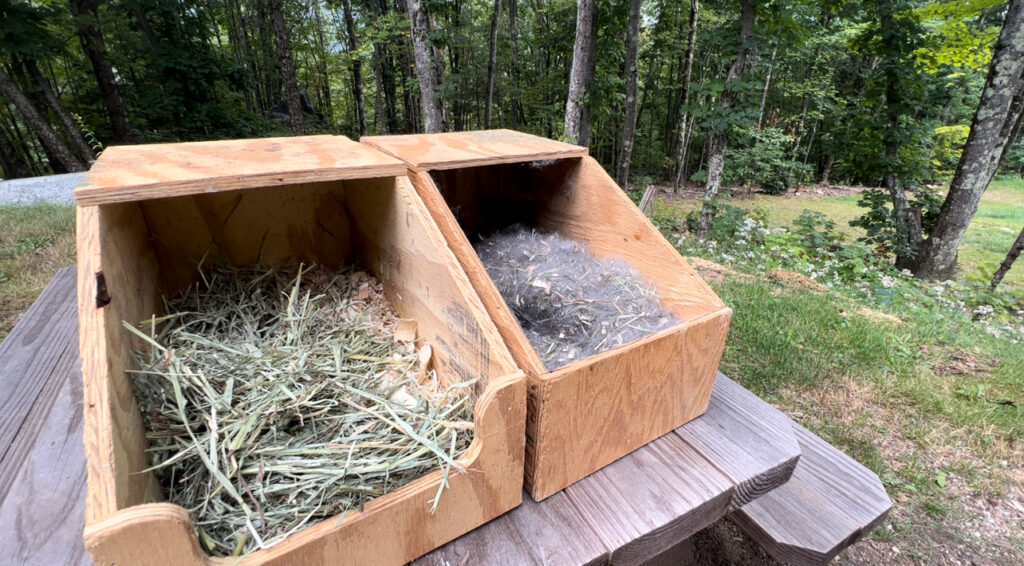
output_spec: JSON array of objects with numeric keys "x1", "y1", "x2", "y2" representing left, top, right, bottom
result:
[{"x1": 564, "y1": 0, "x2": 597, "y2": 145}]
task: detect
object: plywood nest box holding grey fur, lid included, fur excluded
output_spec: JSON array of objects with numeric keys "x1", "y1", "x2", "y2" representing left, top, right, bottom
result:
[{"x1": 361, "y1": 130, "x2": 732, "y2": 500}]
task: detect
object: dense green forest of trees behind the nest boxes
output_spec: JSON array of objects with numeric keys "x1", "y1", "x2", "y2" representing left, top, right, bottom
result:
[{"x1": 0, "y1": 0, "x2": 1024, "y2": 276}]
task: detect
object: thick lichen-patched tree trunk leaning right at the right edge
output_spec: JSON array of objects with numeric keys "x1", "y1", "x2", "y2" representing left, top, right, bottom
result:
[{"x1": 913, "y1": 0, "x2": 1024, "y2": 279}]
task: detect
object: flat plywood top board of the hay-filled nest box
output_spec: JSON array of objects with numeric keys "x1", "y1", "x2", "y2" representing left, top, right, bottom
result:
[{"x1": 75, "y1": 135, "x2": 406, "y2": 205}]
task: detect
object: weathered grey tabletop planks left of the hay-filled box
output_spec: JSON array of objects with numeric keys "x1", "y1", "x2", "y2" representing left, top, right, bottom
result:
[{"x1": 0, "y1": 267, "x2": 88, "y2": 566}]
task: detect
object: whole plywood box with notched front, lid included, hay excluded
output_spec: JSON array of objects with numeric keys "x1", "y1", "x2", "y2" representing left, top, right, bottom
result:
[{"x1": 70, "y1": 136, "x2": 526, "y2": 566}]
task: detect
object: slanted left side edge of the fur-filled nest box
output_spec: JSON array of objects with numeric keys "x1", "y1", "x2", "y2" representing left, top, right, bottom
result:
[{"x1": 409, "y1": 171, "x2": 545, "y2": 380}]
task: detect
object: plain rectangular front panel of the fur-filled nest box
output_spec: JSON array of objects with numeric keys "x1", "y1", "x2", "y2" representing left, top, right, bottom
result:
[{"x1": 526, "y1": 307, "x2": 732, "y2": 500}]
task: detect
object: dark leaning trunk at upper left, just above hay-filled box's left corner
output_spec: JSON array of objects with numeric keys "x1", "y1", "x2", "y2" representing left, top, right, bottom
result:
[{"x1": 69, "y1": 0, "x2": 134, "y2": 143}]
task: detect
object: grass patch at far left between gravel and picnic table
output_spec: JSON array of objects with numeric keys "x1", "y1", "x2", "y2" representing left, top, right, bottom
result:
[{"x1": 0, "y1": 205, "x2": 75, "y2": 340}]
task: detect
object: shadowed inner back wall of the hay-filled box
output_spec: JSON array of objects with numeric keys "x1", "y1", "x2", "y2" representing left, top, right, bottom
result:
[{"x1": 140, "y1": 182, "x2": 352, "y2": 295}]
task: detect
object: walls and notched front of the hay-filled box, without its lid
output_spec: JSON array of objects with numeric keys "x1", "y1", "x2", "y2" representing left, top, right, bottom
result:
[{"x1": 79, "y1": 173, "x2": 526, "y2": 566}]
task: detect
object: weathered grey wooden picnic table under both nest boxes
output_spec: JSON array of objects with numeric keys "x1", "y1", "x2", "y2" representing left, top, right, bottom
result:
[{"x1": 0, "y1": 268, "x2": 891, "y2": 566}]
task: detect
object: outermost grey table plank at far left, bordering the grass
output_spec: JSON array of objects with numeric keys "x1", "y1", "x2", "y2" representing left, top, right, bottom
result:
[{"x1": 0, "y1": 268, "x2": 78, "y2": 472}]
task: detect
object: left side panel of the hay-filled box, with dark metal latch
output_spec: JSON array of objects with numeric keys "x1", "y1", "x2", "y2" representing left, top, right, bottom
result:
[{"x1": 78, "y1": 204, "x2": 162, "y2": 523}]
